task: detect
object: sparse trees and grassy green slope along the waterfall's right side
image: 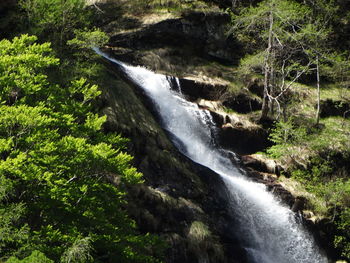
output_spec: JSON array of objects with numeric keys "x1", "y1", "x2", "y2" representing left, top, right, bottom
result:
[{"x1": 232, "y1": 0, "x2": 350, "y2": 259}]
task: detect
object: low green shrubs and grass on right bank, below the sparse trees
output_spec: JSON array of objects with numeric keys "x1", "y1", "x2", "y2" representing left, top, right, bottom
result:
[{"x1": 267, "y1": 117, "x2": 350, "y2": 258}]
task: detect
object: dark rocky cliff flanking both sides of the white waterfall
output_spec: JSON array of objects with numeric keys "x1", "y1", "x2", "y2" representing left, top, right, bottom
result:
[{"x1": 90, "y1": 2, "x2": 336, "y2": 262}]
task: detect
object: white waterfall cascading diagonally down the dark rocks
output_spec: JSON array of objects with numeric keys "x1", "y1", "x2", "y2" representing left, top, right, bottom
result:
[{"x1": 95, "y1": 50, "x2": 328, "y2": 263}]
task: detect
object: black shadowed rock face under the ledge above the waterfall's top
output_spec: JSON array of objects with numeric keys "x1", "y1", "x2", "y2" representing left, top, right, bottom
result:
[{"x1": 110, "y1": 12, "x2": 234, "y2": 65}]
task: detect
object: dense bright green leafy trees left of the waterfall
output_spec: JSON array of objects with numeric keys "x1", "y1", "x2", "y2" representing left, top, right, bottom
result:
[{"x1": 0, "y1": 35, "x2": 164, "y2": 262}]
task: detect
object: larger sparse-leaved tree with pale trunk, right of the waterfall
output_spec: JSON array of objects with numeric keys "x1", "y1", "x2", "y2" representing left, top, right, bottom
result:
[{"x1": 232, "y1": 0, "x2": 332, "y2": 121}]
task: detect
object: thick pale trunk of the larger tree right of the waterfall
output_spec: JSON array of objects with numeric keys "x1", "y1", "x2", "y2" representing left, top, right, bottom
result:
[{"x1": 260, "y1": 11, "x2": 273, "y2": 120}]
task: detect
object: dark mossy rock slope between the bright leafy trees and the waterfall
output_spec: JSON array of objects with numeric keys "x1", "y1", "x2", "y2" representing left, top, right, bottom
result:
[{"x1": 98, "y1": 60, "x2": 245, "y2": 263}]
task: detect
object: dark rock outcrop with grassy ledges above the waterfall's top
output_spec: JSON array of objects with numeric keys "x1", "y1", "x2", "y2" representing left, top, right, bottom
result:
[{"x1": 99, "y1": 3, "x2": 239, "y2": 77}]
